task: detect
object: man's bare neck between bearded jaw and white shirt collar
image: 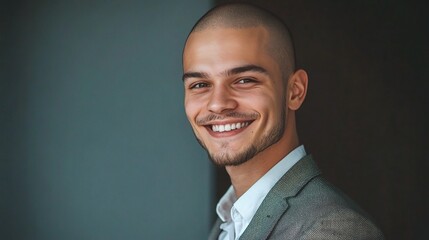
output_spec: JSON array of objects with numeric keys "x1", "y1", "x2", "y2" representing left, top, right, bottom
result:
[{"x1": 226, "y1": 113, "x2": 299, "y2": 198}]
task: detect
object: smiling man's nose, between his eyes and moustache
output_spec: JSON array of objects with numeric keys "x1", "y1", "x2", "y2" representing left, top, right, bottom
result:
[{"x1": 207, "y1": 87, "x2": 238, "y2": 113}]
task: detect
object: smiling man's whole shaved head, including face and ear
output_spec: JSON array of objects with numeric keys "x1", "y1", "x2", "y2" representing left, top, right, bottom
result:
[{"x1": 182, "y1": 4, "x2": 307, "y2": 166}]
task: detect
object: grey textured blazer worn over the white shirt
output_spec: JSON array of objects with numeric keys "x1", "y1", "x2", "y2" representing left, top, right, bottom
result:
[{"x1": 209, "y1": 155, "x2": 384, "y2": 240}]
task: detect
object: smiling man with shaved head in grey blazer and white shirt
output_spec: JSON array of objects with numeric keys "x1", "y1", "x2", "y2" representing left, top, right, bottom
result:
[{"x1": 183, "y1": 4, "x2": 383, "y2": 240}]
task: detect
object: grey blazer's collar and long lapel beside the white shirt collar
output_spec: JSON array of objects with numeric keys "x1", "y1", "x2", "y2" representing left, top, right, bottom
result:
[{"x1": 237, "y1": 155, "x2": 320, "y2": 240}]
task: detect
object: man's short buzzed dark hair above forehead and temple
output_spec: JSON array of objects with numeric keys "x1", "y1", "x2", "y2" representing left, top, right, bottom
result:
[{"x1": 189, "y1": 3, "x2": 295, "y2": 79}]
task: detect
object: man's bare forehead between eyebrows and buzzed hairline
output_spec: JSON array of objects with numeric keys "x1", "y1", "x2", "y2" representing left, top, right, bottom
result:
[{"x1": 183, "y1": 27, "x2": 275, "y2": 71}]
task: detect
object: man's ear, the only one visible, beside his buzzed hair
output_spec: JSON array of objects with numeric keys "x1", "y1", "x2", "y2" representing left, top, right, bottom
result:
[{"x1": 288, "y1": 69, "x2": 308, "y2": 110}]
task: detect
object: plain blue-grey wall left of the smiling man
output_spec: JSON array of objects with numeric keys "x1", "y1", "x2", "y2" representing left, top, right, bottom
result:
[{"x1": 0, "y1": 0, "x2": 212, "y2": 240}]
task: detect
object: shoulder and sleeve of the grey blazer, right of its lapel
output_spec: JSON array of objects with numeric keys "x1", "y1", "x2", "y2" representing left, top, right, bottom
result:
[{"x1": 270, "y1": 175, "x2": 383, "y2": 239}]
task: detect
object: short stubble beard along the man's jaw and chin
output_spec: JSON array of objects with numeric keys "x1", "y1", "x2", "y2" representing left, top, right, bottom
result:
[{"x1": 196, "y1": 106, "x2": 286, "y2": 167}]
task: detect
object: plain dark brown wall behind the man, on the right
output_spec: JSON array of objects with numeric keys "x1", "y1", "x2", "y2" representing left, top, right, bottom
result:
[{"x1": 217, "y1": 0, "x2": 429, "y2": 240}]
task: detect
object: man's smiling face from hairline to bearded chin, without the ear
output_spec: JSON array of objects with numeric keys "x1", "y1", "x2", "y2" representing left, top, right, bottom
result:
[{"x1": 183, "y1": 27, "x2": 286, "y2": 166}]
